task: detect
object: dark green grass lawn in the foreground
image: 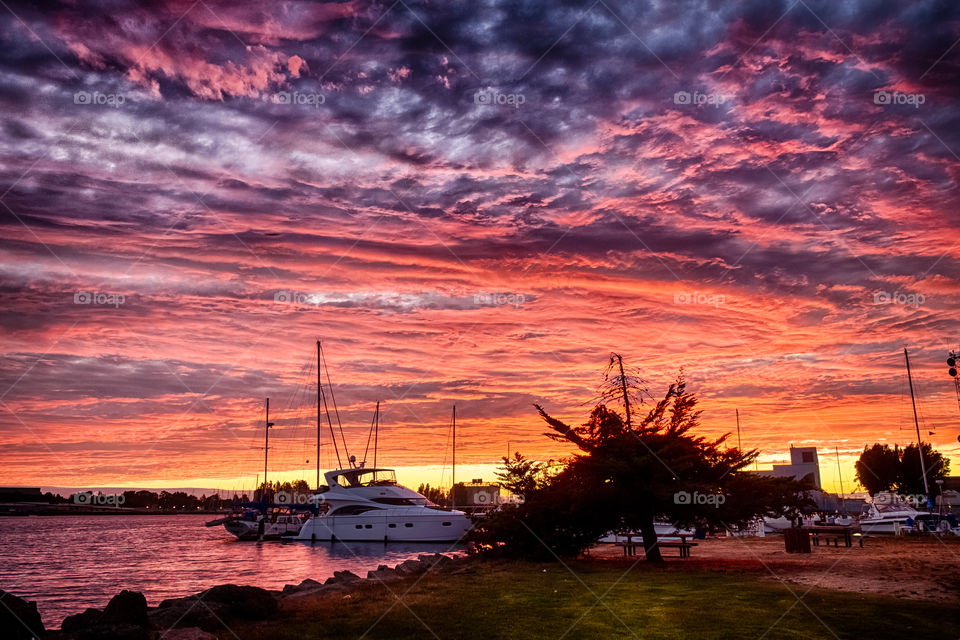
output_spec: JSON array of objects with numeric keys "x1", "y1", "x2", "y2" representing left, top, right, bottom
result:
[{"x1": 231, "y1": 562, "x2": 960, "y2": 640}]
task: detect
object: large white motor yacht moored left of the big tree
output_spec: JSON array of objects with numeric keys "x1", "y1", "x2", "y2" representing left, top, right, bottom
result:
[{"x1": 295, "y1": 467, "x2": 472, "y2": 542}]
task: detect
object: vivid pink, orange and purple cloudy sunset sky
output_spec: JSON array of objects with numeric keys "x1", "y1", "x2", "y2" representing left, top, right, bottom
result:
[{"x1": 0, "y1": 0, "x2": 960, "y2": 491}]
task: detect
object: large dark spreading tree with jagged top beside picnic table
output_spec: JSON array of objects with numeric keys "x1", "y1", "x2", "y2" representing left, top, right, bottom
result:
[{"x1": 474, "y1": 358, "x2": 810, "y2": 562}]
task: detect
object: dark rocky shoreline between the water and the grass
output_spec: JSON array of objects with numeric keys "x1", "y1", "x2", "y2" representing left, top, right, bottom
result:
[{"x1": 0, "y1": 553, "x2": 464, "y2": 640}]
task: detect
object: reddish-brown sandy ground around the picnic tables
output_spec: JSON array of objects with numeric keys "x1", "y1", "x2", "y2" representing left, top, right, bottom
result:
[{"x1": 590, "y1": 535, "x2": 960, "y2": 605}]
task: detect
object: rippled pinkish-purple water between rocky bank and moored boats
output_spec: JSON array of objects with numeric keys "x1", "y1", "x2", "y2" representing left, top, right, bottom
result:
[{"x1": 0, "y1": 515, "x2": 456, "y2": 629}]
